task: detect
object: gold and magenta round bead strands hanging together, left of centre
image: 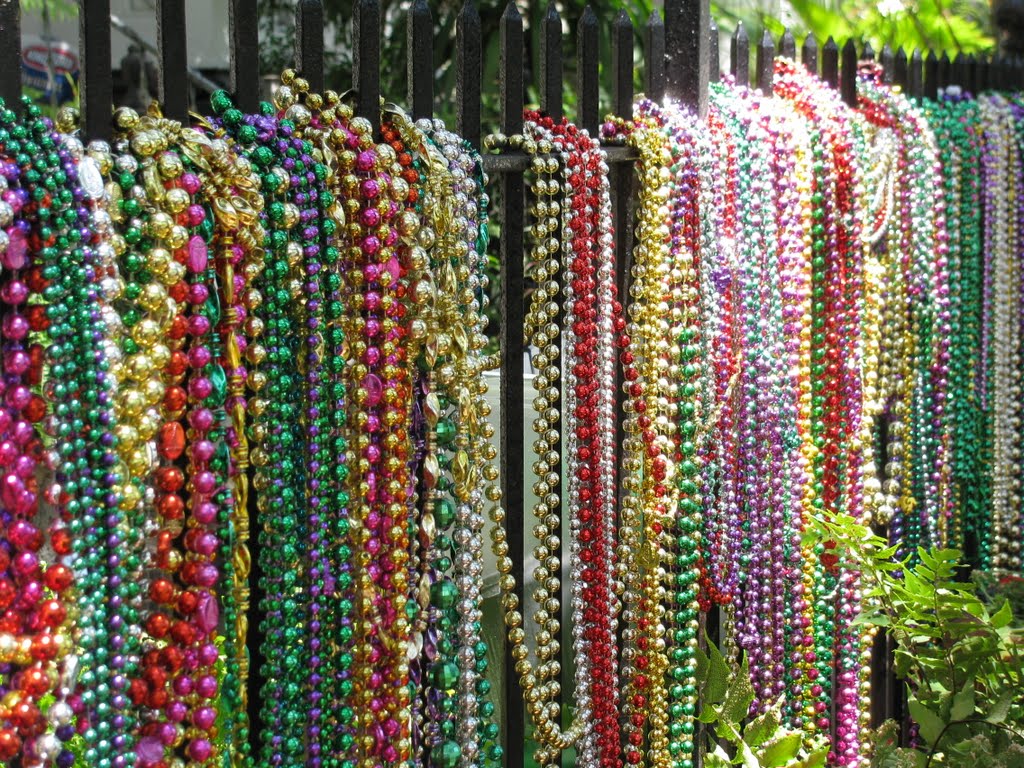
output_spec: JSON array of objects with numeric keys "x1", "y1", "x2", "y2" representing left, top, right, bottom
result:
[{"x1": 344, "y1": 105, "x2": 411, "y2": 766}]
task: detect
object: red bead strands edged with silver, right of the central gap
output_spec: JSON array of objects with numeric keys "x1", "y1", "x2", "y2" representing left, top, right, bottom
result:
[{"x1": 539, "y1": 111, "x2": 620, "y2": 766}]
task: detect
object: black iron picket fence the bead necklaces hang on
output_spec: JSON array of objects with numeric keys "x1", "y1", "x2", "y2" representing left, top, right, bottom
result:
[{"x1": 0, "y1": 0, "x2": 1024, "y2": 766}]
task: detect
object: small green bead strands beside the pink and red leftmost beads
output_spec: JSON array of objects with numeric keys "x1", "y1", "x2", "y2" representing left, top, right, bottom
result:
[{"x1": 12, "y1": 102, "x2": 140, "y2": 768}]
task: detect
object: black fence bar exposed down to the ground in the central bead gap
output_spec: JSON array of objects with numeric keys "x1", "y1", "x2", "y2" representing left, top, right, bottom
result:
[{"x1": 499, "y1": 6, "x2": 526, "y2": 767}]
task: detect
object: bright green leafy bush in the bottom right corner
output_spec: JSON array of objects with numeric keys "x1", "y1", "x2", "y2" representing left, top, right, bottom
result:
[{"x1": 809, "y1": 516, "x2": 1024, "y2": 768}]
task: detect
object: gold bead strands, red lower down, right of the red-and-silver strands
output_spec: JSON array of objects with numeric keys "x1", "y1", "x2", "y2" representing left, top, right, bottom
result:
[{"x1": 598, "y1": 102, "x2": 672, "y2": 765}]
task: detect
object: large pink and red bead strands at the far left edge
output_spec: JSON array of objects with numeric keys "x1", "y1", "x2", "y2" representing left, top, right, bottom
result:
[{"x1": 0, "y1": 109, "x2": 74, "y2": 761}]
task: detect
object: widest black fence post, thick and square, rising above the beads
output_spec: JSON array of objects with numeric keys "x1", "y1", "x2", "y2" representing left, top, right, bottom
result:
[{"x1": 665, "y1": 0, "x2": 711, "y2": 115}]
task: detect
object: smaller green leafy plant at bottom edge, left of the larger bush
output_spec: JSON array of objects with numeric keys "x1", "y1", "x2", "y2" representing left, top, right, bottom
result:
[{"x1": 696, "y1": 642, "x2": 828, "y2": 768}]
